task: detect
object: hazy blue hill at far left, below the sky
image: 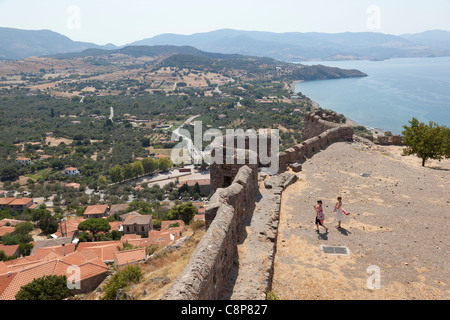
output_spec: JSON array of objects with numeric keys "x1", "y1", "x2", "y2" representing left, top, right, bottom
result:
[{"x1": 0, "y1": 28, "x2": 115, "y2": 60}]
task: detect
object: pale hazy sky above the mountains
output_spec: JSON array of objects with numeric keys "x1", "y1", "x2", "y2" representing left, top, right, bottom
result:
[{"x1": 0, "y1": 0, "x2": 450, "y2": 45}]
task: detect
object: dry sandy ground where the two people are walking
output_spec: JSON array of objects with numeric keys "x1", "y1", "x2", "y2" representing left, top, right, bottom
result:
[{"x1": 272, "y1": 142, "x2": 450, "y2": 300}]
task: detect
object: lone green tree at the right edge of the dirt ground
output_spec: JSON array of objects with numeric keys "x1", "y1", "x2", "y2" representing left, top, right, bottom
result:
[{"x1": 402, "y1": 118, "x2": 450, "y2": 167}]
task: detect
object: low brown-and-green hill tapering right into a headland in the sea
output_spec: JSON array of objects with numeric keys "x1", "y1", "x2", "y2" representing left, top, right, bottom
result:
[{"x1": 0, "y1": 45, "x2": 366, "y2": 89}]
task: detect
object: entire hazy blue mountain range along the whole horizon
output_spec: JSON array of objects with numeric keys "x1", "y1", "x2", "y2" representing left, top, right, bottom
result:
[{"x1": 0, "y1": 27, "x2": 450, "y2": 62}]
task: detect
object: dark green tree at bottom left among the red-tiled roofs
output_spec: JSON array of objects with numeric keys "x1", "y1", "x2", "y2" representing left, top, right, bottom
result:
[{"x1": 16, "y1": 275, "x2": 73, "y2": 300}]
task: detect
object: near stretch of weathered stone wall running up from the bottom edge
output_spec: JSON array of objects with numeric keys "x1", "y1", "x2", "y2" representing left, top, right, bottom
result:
[{"x1": 161, "y1": 166, "x2": 258, "y2": 300}]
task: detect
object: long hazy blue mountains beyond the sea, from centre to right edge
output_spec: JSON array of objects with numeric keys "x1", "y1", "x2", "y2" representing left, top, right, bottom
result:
[{"x1": 130, "y1": 29, "x2": 450, "y2": 62}]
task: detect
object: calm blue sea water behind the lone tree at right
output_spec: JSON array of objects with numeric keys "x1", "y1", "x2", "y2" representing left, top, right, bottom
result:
[{"x1": 295, "y1": 57, "x2": 450, "y2": 134}]
